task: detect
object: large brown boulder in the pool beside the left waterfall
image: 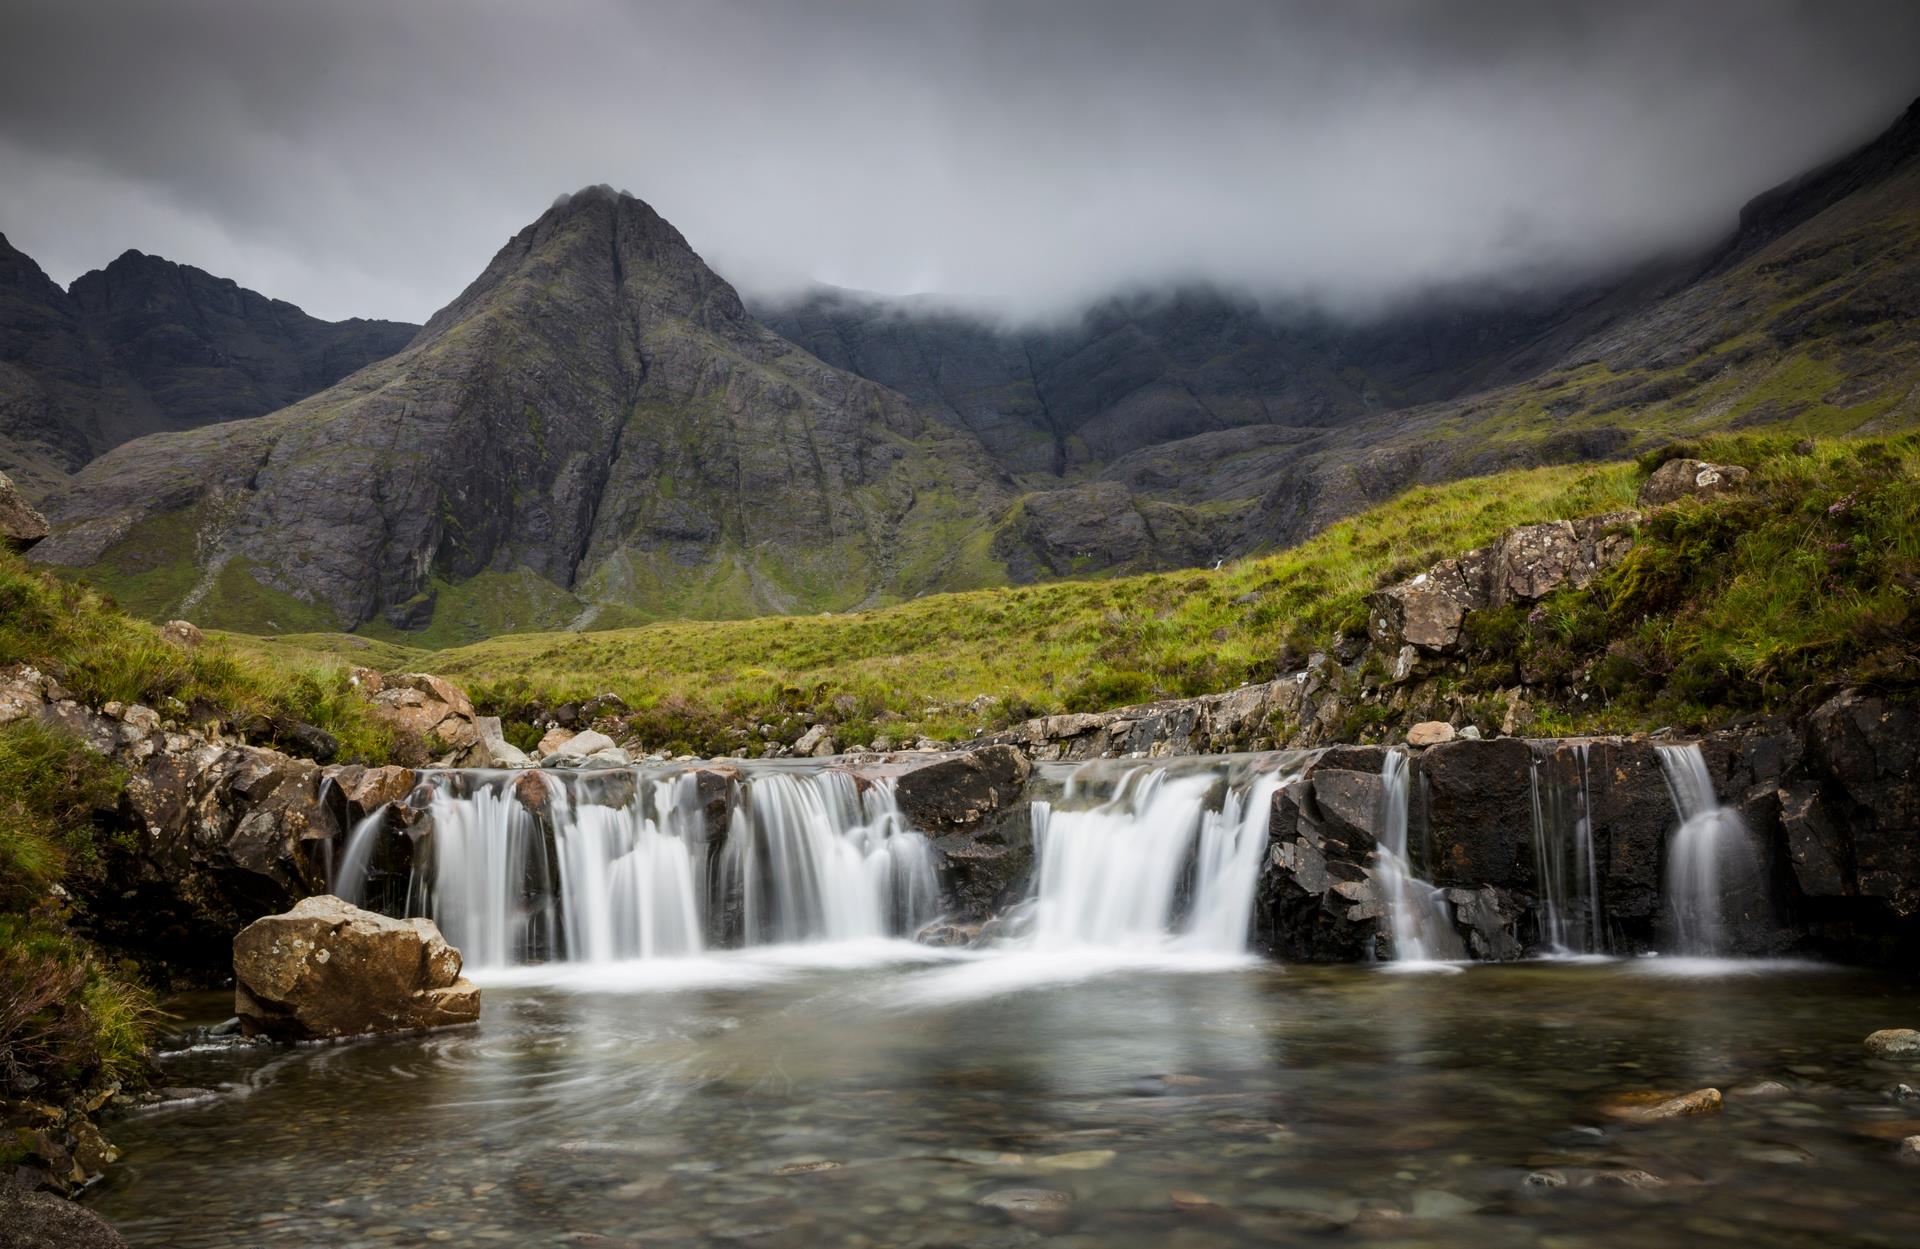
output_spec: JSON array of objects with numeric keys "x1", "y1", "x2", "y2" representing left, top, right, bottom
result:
[{"x1": 234, "y1": 896, "x2": 480, "y2": 1040}]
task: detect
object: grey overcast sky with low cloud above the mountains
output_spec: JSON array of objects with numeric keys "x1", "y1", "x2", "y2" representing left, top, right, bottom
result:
[{"x1": 0, "y1": 0, "x2": 1920, "y2": 320}]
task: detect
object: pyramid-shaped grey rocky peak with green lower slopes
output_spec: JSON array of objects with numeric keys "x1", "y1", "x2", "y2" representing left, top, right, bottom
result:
[{"x1": 36, "y1": 188, "x2": 1010, "y2": 637}]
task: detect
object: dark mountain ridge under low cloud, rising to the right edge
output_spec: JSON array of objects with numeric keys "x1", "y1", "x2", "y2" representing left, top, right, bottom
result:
[{"x1": 758, "y1": 102, "x2": 1920, "y2": 576}]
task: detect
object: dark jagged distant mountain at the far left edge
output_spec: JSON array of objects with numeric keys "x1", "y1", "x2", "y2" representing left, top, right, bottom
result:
[{"x1": 0, "y1": 236, "x2": 419, "y2": 493}]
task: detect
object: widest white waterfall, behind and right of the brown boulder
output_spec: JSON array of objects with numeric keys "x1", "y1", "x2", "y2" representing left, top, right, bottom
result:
[{"x1": 407, "y1": 767, "x2": 941, "y2": 969}]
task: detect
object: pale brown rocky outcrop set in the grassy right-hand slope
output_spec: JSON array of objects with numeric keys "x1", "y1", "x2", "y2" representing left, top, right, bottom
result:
[{"x1": 1367, "y1": 512, "x2": 1640, "y2": 654}]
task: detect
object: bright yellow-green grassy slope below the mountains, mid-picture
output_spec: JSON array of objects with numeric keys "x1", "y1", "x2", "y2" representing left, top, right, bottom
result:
[{"x1": 389, "y1": 464, "x2": 1642, "y2": 754}]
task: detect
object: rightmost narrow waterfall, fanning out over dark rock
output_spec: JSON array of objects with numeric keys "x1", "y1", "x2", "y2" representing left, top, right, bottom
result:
[{"x1": 1659, "y1": 744, "x2": 1753, "y2": 955}]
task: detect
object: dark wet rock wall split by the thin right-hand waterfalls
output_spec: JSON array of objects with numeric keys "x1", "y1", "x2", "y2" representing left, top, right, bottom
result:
[{"x1": 1260, "y1": 691, "x2": 1920, "y2": 963}]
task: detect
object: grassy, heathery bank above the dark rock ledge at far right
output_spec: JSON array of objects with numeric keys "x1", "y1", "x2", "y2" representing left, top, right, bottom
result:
[{"x1": 1467, "y1": 434, "x2": 1920, "y2": 731}]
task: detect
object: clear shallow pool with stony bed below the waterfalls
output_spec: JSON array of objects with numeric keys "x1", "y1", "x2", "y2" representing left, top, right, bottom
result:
[{"x1": 90, "y1": 944, "x2": 1920, "y2": 1249}]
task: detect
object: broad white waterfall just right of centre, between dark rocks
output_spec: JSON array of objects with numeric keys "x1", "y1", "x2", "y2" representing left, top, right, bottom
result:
[{"x1": 1027, "y1": 760, "x2": 1284, "y2": 954}]
